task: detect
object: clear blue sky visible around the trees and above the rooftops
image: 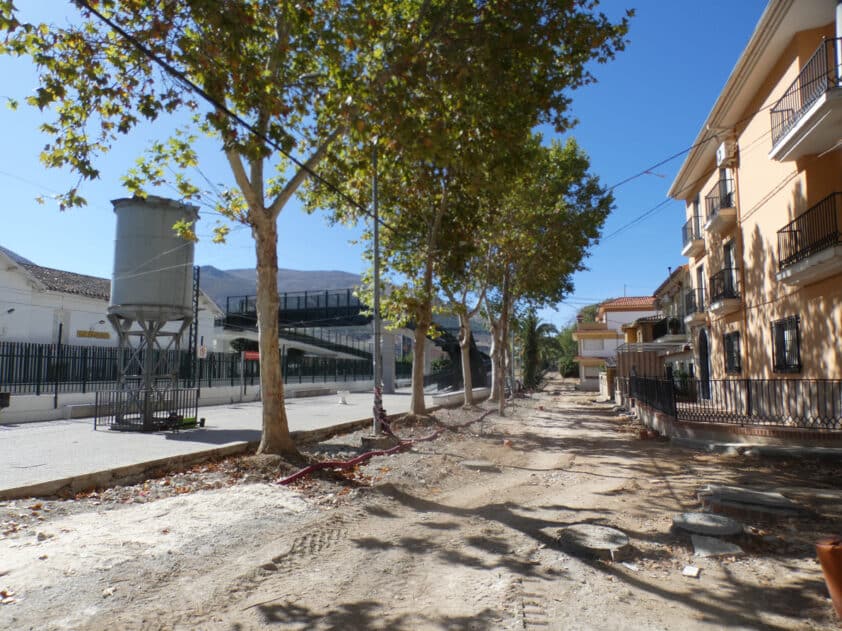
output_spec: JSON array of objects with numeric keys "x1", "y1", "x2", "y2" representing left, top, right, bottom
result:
[{"x1": 0, "y1": 0, "x2": 766, "y2": 325}]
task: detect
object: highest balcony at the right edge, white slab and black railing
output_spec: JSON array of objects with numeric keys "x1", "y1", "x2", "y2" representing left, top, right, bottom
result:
[{"x1": 769, "y1": 38, "x2": 842, "y2": 162}]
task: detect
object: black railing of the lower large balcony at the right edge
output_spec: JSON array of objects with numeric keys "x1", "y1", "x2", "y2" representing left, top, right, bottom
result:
[{"x1": 778, "y1": 193, "x2": 842, "y2": 269}]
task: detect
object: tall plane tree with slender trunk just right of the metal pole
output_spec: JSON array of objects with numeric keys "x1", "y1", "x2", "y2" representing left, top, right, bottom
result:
[{"x1": 309, "y1": 1, "x2": 627, "y2": 414}]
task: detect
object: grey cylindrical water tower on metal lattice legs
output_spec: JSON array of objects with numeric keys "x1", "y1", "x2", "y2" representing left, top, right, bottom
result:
[{"x1": 108, "y1": 196, "x2": 198, "y2": 430}]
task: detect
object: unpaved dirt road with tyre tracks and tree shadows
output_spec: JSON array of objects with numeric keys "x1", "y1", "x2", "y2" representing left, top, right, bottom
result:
[{"x1": 0, "y1": 383, "x2": 842, "y2": 631}]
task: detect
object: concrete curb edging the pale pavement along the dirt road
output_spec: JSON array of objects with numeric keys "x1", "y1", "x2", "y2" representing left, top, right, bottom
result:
[{"x1": 0, "y1": 406, "x2": 441, "y2": 501}]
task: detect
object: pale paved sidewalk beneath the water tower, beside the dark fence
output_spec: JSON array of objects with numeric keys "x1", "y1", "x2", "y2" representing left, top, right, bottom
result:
[{"x1": 0, "y1": 392, "x2": 431, "y2": 498}]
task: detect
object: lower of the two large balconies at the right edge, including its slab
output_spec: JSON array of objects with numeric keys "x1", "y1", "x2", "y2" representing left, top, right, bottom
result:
[{"x1": 776, "y1": 193, "x2": 842, "y2": 285}]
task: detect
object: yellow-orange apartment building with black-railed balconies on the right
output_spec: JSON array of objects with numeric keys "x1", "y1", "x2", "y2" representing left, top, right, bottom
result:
[{"x1": 669, "y1": 0, "x2": 842, "y2": 392}]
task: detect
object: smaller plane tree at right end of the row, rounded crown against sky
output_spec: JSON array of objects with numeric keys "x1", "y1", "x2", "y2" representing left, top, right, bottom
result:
[{"x1": 486, "y1": 136, "x2": 614, "y2": 413}]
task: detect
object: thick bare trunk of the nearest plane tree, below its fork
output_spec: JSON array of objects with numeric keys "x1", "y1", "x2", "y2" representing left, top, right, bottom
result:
[{"x1": 252, "y1": 213, "x2": 298, "y2": 456}]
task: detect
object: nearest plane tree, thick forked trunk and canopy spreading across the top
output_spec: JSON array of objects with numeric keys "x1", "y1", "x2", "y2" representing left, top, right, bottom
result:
[{"x1": 0, "y1": 0, "x2": 627, "y2": 444}]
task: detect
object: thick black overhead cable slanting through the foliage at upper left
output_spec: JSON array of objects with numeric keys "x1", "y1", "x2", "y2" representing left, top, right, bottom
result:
[{"x1": 72, "y1": 0, "x2": 393, "y2": 230}]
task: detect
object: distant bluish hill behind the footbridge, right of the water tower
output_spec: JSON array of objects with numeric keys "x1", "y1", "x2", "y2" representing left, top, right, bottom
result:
[{"x1": 200, "y1": 265, "x2": 360, "y2": 309}]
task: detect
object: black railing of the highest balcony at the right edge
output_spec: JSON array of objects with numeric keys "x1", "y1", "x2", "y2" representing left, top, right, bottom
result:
[{"x1": 770, "y1": 38, "x2": 842, "y2": 146}]
